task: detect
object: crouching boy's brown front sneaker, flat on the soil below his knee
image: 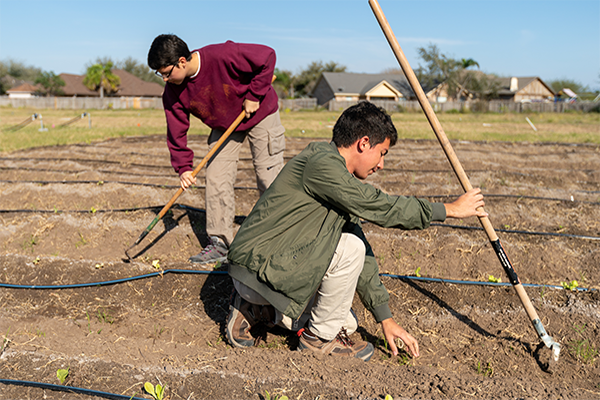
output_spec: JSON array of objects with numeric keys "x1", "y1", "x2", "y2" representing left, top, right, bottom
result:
[{"x1": 298, "y1": 328, "x2": 375, "y2": 361}]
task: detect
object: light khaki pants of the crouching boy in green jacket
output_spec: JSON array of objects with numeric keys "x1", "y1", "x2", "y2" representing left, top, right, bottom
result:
[{"x1": 233, "y1": 233, "x2": 366, "y2": 340}]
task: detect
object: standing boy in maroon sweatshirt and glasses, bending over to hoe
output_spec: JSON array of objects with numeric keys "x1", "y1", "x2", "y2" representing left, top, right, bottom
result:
[{"x1": 148, "y1": 35, "x2": 285, "y2": 264}]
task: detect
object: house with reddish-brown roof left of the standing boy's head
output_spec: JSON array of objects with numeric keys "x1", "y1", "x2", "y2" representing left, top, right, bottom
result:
[{"x1": 59, "y1": 69, "x2": 163, "y2": 97}]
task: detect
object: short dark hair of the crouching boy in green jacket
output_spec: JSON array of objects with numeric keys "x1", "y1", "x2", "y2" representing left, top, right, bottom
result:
[{"x1": 332, "y1": 101, "x2": 398, "y2": 147}]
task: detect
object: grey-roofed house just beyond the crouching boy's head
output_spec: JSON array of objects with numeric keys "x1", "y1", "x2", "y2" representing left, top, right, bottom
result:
[{"x1": 311, "y1": 72, "x2": 414, "y2": 105}]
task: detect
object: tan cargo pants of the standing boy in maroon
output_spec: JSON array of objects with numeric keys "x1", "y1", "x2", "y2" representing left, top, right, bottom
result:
[{"x1": 206, "y1": 111, "x2": 285, "y2": 246}]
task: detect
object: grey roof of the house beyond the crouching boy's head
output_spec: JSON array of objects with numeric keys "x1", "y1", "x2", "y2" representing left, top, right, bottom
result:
[{"x1": 322, "y1": 72, "x2": 414, "y2": 98}]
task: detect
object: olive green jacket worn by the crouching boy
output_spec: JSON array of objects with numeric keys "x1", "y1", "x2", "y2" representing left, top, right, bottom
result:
[{"x1": 228, "y1": 142, "x2": 446, "y2": 322}]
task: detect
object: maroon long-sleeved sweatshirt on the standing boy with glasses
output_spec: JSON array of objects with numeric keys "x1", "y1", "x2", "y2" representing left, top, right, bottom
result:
[{"x1": 163, "y1": 41, "x2": 278, "y2": 175}]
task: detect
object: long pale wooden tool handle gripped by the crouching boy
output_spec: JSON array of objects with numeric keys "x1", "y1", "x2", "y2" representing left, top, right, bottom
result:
[{"x1": 369, "y1": 0, "x2": 539, "y2": 321}]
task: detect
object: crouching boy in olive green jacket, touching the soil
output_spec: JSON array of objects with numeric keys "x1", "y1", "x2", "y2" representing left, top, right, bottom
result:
[{"x1": 226, "y1": 102, "x2": 487, "y2": 360}]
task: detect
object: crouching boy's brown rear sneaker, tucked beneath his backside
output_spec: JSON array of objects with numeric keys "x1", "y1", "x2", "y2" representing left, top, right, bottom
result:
[{"x1": 225, "y1": 289, "x2": 275, "y2": 348}]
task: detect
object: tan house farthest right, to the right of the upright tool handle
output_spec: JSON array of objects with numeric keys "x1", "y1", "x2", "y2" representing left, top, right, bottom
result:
[{"x1": 496, "y1": 76, "x2": 556, "y2": 103}]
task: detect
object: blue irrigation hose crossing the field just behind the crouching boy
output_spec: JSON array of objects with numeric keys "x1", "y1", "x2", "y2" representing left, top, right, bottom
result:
[{"x1": 0, "y1": 269, "x2": 596, "y2": 292}]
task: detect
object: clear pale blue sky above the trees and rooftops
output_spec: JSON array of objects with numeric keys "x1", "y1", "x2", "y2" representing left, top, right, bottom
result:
[{"x1": 0, "y1": 0, "x2": 600, "y2": 90}]
